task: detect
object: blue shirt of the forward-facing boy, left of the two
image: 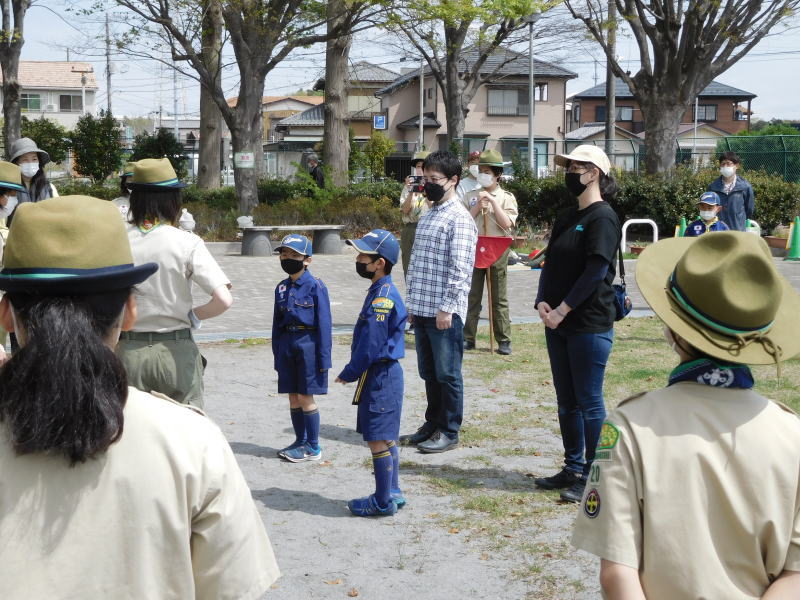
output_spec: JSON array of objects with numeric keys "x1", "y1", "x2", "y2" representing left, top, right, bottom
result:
[{"x1": 272, "y1": 269, "x2": 333, "y2": 370}]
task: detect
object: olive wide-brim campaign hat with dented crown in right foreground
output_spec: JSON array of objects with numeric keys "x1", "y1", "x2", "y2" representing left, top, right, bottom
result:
[{"x1": 636, "y1": 231, "x2": 800, "y2": 365}]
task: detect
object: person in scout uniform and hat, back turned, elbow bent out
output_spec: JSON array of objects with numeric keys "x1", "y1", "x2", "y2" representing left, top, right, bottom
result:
[{"x1": 117, "y1": 158, "x2": 233, "y2": 407}]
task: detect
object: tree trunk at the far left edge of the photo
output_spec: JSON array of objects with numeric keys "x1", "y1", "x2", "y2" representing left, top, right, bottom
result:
[{"x1": 0, "y1": 0, "x2": 31, "y2": 155}]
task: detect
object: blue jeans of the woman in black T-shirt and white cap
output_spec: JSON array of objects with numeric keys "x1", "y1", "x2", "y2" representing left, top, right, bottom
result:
[{"x1": 545, "y1": 328, "x2": 614, "y2": 477}]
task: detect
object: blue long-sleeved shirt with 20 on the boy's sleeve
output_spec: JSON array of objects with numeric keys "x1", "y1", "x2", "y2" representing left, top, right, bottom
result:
[{"x1": 339, "y1": 275, "x2": 408, "y2": 382}]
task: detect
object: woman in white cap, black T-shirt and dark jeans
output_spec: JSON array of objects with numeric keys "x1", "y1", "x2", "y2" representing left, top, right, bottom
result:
[{"x1": 534, "y1": 145, "x2": 622, "y2": 502}]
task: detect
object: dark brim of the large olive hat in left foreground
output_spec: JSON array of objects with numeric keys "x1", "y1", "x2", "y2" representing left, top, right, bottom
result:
[{"x1": 0, "y1": 263, "x2": 158, "y2": 295}]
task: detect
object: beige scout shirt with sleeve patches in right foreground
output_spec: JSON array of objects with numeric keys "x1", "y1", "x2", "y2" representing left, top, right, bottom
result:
[{"x1": 572, "y1": 382, "x2": 800, "y2": 600}]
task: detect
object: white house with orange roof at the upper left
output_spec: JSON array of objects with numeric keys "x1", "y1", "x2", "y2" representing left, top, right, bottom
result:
[{"x1": 3, "y1": 60, "x2": 98, "y2": 129}]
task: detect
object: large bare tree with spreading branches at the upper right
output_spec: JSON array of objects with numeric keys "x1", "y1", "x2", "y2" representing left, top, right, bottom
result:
[{"x1": 566, "y1": 0, "x2": 800, "y2": 173}]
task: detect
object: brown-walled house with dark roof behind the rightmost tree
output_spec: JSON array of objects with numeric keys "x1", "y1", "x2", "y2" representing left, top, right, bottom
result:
[{"x1": 569, "y1": 79, "x2": 756, "y2": 135}]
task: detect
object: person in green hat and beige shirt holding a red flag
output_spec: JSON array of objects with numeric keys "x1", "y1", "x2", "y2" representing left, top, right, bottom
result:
[{"x1": 462, "y1": 150, "x2": 519, "y2": 354}]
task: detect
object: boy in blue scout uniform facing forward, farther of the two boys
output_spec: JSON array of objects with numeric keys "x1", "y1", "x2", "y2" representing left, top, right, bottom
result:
[{"x1": 272, "y1": 234, "x2": 332, "y2": 462}]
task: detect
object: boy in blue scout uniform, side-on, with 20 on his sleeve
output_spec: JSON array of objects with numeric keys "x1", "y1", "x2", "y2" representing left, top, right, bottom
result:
[{"x1": 336, "y1": 229, "x2": 408, "y2": 517}]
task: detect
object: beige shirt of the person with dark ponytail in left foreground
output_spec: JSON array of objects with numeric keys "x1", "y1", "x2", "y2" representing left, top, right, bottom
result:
[{"x1": 0, "y1": 388, "x2": 280, "y2": 600}]
